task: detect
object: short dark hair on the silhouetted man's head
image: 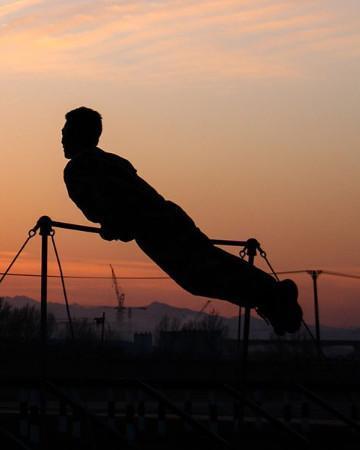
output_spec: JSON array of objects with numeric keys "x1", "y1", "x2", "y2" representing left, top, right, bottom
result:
[{"x1": 65, "y1": 106, "x2": 102, "y2": 145}]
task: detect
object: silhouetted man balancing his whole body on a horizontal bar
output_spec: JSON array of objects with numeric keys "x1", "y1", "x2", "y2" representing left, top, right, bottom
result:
[{"x1": 62, "y1": 107, "x2": 302, "y2": 334}]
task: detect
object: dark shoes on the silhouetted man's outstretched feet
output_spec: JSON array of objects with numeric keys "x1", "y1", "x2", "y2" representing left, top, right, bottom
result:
[{"x1": 256, "y1": 280, "x2": 303, "y2": 336}]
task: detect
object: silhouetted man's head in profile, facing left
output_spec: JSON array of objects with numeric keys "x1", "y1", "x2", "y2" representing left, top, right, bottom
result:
[{"x1": 61, "y1": 106, "x2": 102, "y2": 159}]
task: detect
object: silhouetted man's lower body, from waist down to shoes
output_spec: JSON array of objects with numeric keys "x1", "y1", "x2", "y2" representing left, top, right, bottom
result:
[{"x1": 137, "y1": 233, "x2": 302, "y2": 334}]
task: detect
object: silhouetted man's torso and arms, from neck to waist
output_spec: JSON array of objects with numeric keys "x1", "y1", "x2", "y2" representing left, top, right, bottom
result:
[{"x1": 64, "y1": 148, "x2": 207, "y2": 247}]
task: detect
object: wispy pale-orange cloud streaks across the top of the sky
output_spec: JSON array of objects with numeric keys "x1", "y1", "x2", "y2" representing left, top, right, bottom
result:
[{"x1": 0, "y1": 0, "x2": 360, "y2": 82}]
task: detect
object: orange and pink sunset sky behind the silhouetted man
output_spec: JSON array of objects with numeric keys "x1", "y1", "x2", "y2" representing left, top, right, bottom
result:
[{"x1": 0, "y1": 0, "x2": 360, "y2": 326}]
